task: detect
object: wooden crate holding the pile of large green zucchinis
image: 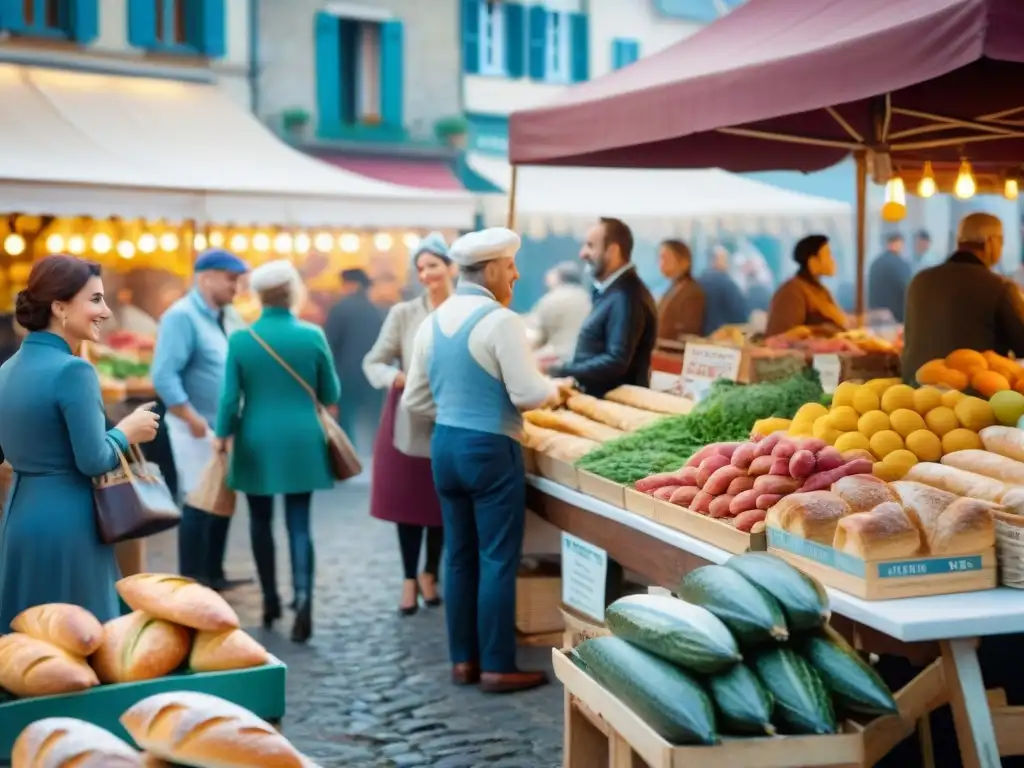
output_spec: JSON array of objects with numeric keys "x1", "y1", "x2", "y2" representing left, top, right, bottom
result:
[{"x1": 553, "y1": 649, "x2": 944, "y2": 768}]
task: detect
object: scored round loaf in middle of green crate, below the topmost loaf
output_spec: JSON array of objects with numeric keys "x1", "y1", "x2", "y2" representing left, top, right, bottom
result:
[{"x1": 90, "y1": 610, "x2": 191, "y2": 683}]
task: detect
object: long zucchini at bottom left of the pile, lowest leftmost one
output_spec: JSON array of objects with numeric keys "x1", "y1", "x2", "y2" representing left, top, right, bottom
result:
[{"x1": 575, "y1": 637, "x2": 718, "y2": 744}]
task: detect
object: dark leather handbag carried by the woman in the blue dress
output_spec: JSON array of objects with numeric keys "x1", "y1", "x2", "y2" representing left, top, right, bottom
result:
[{"x1": 92, "y1": 441, "x2": 181, "y2": 544}]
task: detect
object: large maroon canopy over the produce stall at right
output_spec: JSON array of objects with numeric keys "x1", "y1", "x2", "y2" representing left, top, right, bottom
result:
[{"x1": 509, "y1": 0, "x2": 1024, "y2": 171}]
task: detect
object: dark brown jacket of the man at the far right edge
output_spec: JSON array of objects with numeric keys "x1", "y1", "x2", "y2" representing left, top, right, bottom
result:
[{"x1": 903, "y1": 251, "x2": 1024, "y2": 381}]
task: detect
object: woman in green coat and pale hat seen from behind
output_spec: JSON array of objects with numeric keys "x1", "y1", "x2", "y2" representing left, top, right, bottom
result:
[{"x1": 216, "y1": 260, "x2": 341, "y2": 643}]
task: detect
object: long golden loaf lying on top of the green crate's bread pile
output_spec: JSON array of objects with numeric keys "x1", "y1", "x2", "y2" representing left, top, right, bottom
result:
[{"x1": 117, "y1": 573, "x2": 239, "y2": 632}]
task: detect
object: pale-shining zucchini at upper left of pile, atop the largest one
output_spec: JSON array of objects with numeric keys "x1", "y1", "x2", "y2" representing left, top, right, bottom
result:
[{"x1": 604, "y1": 595, "x2": 742, "y2": 675}]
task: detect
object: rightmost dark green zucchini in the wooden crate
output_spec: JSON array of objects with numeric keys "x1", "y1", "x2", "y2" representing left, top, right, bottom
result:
[{"x1": 800, "y1": 627, "x2": 899, "y2": 715}]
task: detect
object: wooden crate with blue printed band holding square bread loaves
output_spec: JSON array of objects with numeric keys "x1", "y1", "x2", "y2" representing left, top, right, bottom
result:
[{"x1": 767, "y1": 527, "x2": 996, "y2": 600}]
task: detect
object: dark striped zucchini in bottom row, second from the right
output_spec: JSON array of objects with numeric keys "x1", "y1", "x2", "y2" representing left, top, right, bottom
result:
[{"x1": 754, "y1": 648, "x2": 836, "y2": 734}]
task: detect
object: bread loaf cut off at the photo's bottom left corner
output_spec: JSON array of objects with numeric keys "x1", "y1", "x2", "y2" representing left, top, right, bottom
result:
[{"x1": 10, "y1": 718, "x2": 146, "y2": 768}]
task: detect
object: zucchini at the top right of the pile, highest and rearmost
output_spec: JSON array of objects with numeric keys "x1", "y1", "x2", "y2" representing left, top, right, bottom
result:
[{"x1": 725, "y1": 552, "x2": 830, "y2": 633}]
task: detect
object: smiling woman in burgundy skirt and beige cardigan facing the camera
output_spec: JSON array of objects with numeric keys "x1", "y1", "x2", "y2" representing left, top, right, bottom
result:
[{"x1": 362, "y1": 232, "x2": 453, "y2": 615}]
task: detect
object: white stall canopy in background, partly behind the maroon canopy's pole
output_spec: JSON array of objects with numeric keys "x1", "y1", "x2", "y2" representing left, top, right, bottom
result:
[{"x1": 468, "y1": 154, "x2": 851, "y2": 240}]
